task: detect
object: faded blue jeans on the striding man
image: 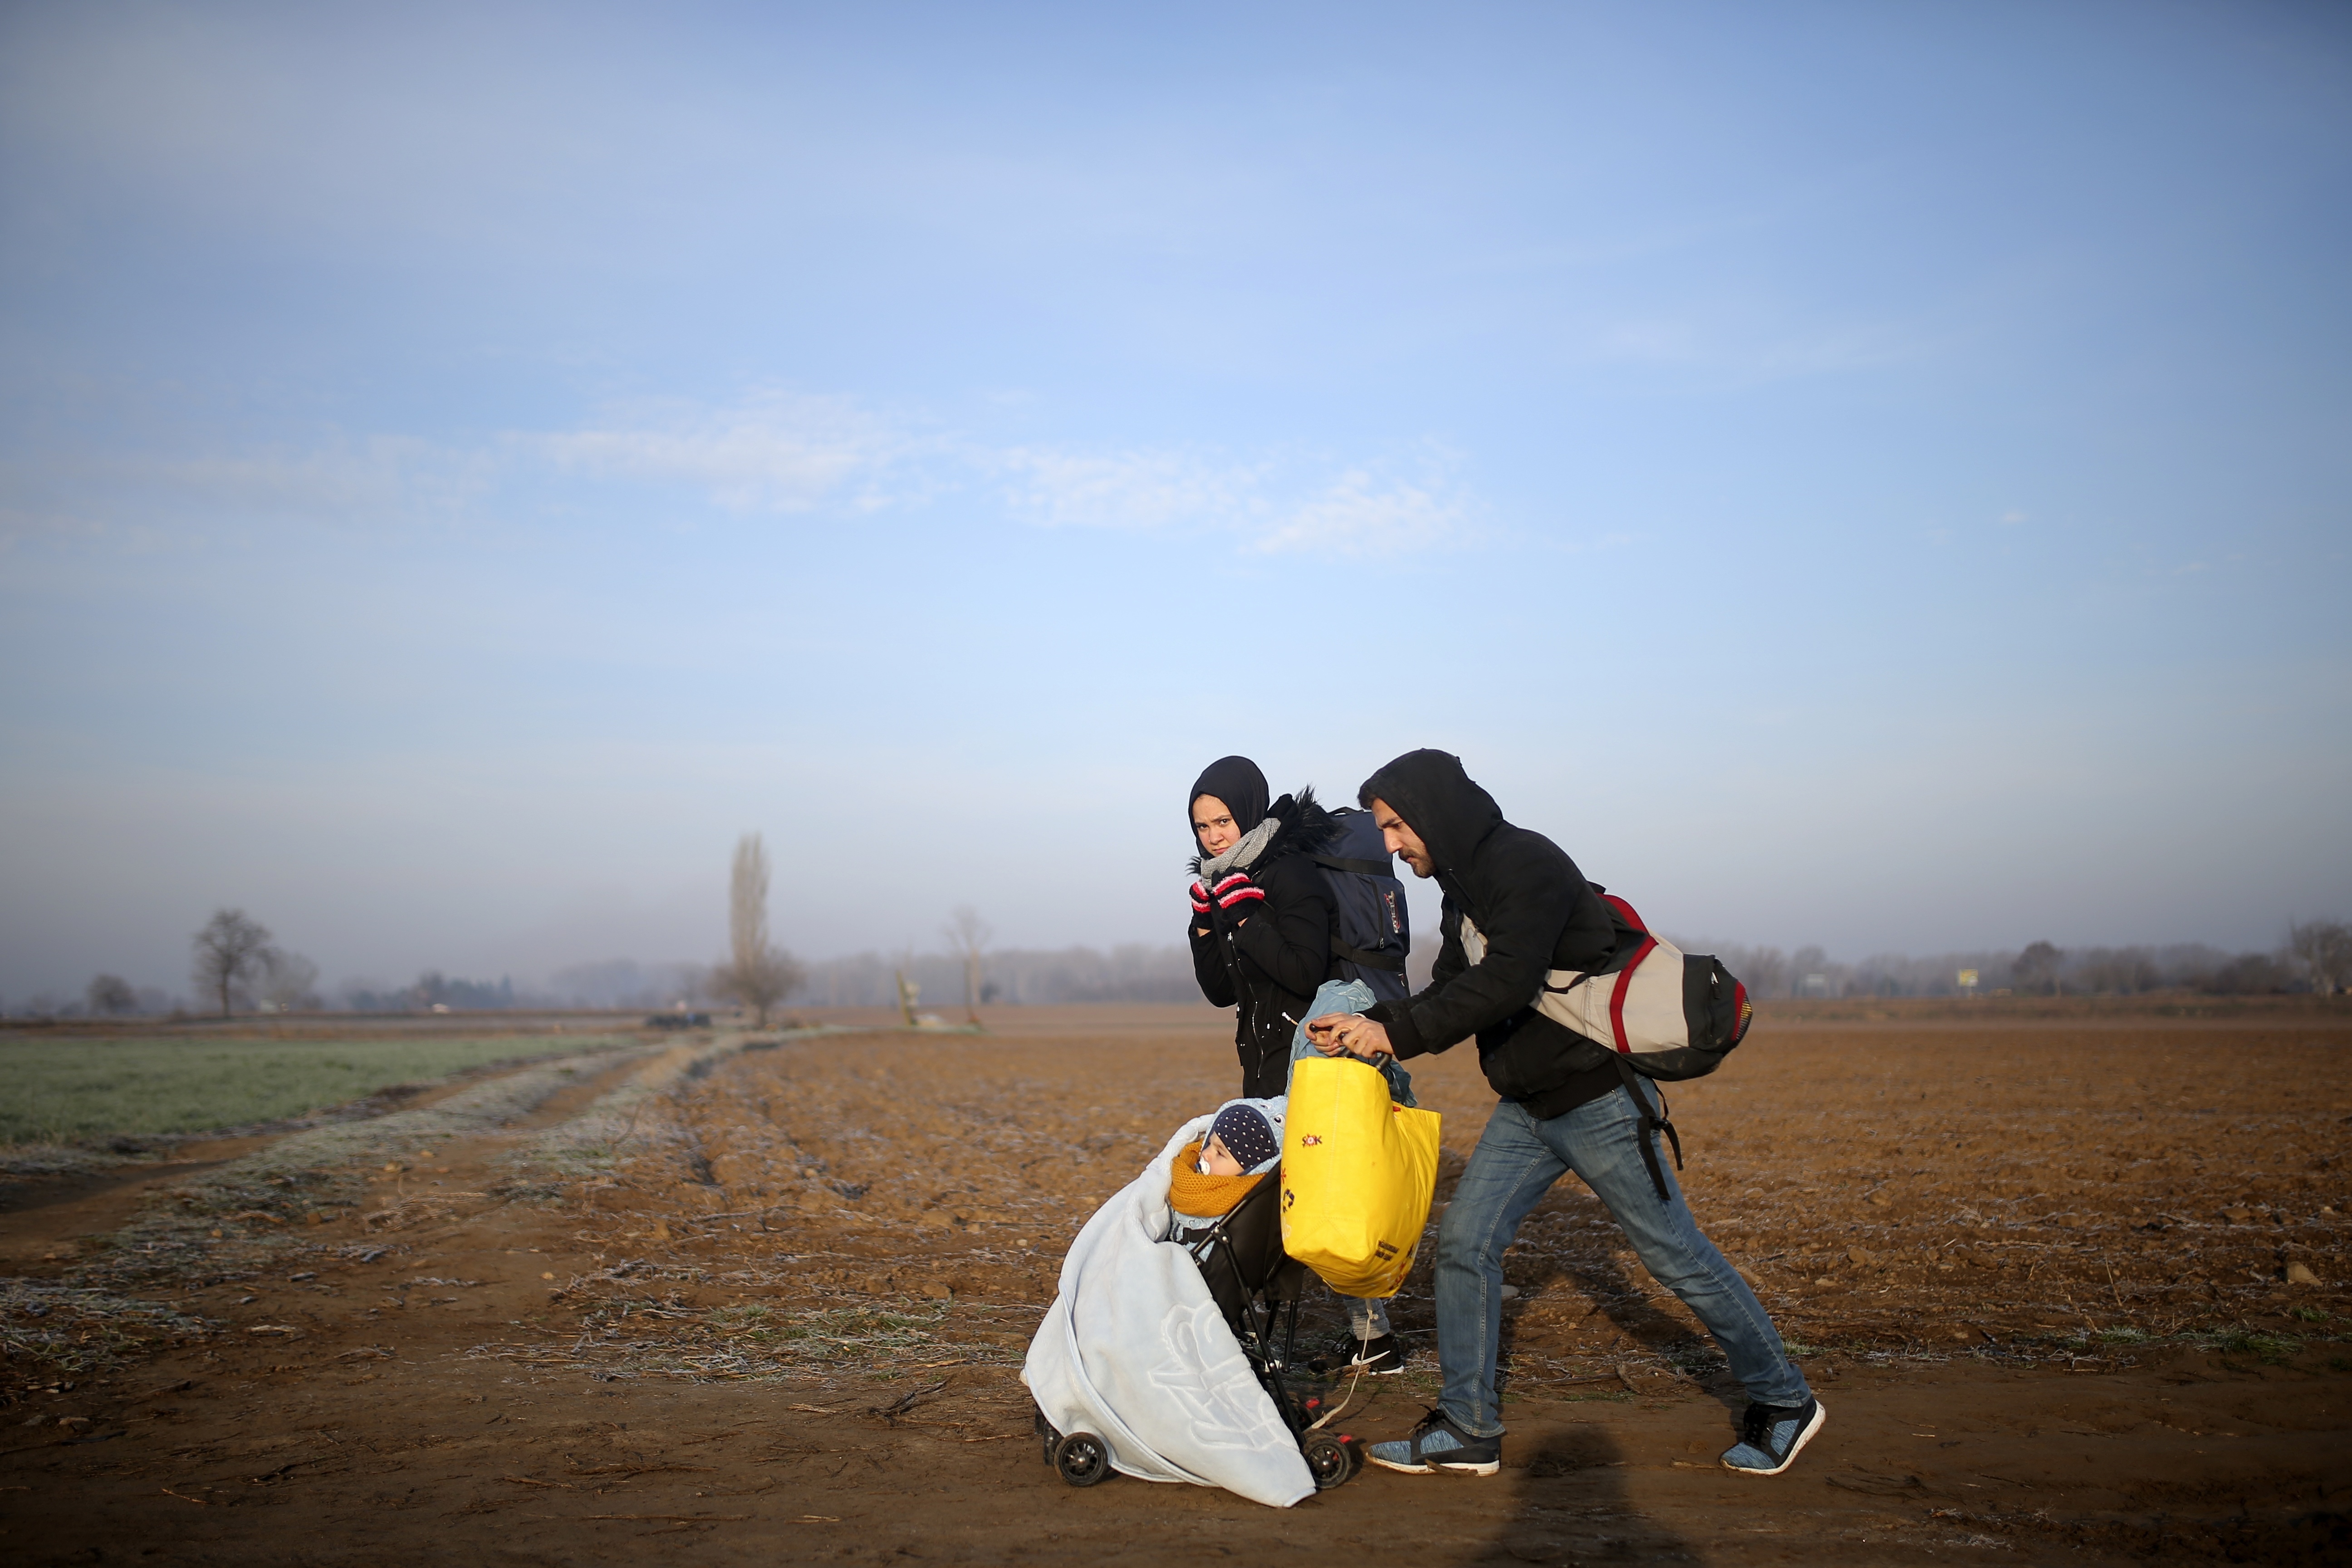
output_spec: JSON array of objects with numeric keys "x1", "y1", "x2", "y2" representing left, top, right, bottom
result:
[{"x1": 1437, "y1": 1084, "x2": 1808, "y2": 1436}]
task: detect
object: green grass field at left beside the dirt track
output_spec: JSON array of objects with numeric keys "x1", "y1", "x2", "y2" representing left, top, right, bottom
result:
[{"x1": 0, "y1": 1034, "x2": 621, "y2": 1142}]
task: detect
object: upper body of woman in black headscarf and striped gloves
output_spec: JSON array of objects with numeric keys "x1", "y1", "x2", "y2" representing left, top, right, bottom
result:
[{"x1": 1186, "y1": 757, "x2": 1331, "y2": 1100}]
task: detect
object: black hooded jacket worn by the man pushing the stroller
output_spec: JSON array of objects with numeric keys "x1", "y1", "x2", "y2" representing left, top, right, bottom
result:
[{"x1": 1357, "y1": 750, "x2": 1618, "y2": 1117}]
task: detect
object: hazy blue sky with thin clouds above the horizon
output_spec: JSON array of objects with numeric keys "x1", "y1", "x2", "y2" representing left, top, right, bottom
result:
[{"x1": 0, "y1": 5, "x2": 2352, "y2": 999}]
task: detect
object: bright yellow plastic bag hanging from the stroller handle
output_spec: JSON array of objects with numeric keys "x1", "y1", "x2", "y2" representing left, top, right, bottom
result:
[{"x1": 1282, "y1": 1055, "x2": 1437, "y2": 1300}]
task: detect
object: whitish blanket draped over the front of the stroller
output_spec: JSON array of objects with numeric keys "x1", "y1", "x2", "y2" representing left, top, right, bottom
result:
[{"x1": 1021, "y1": 1117, "x2": 1315, "y2": 1509}]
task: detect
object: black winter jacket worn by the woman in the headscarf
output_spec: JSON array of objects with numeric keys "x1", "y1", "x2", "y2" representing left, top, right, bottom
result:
[{"x1": 1186, "y1": 790, "x2": 1333, "y2": 1100}]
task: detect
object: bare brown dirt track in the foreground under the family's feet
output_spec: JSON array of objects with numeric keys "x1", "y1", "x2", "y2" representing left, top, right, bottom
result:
[{"x1": 0, "y1": 1335, "x2": 2352, "y2": 1563}]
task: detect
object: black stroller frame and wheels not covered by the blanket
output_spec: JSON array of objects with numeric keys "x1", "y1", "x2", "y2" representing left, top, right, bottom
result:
[{"x1": 1035, "y1": 1166, "x2": 1364, "y2": 1493}]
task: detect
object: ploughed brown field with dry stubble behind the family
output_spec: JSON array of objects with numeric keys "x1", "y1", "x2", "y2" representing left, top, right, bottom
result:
[{"x1": 519, "y1": 1023, "x2": 2352, "y2": 1399}]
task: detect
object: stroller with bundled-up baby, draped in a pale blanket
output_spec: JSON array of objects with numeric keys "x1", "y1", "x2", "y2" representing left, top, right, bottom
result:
[{"x1": 1023, "y1": 1100, "x2": 1362, "y2": 1507}]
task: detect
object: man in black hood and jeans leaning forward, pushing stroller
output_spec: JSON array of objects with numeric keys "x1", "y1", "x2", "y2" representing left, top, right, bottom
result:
[{"x1": 1308, "y1": 750, "x2": 1823, "y2": 1476}]
